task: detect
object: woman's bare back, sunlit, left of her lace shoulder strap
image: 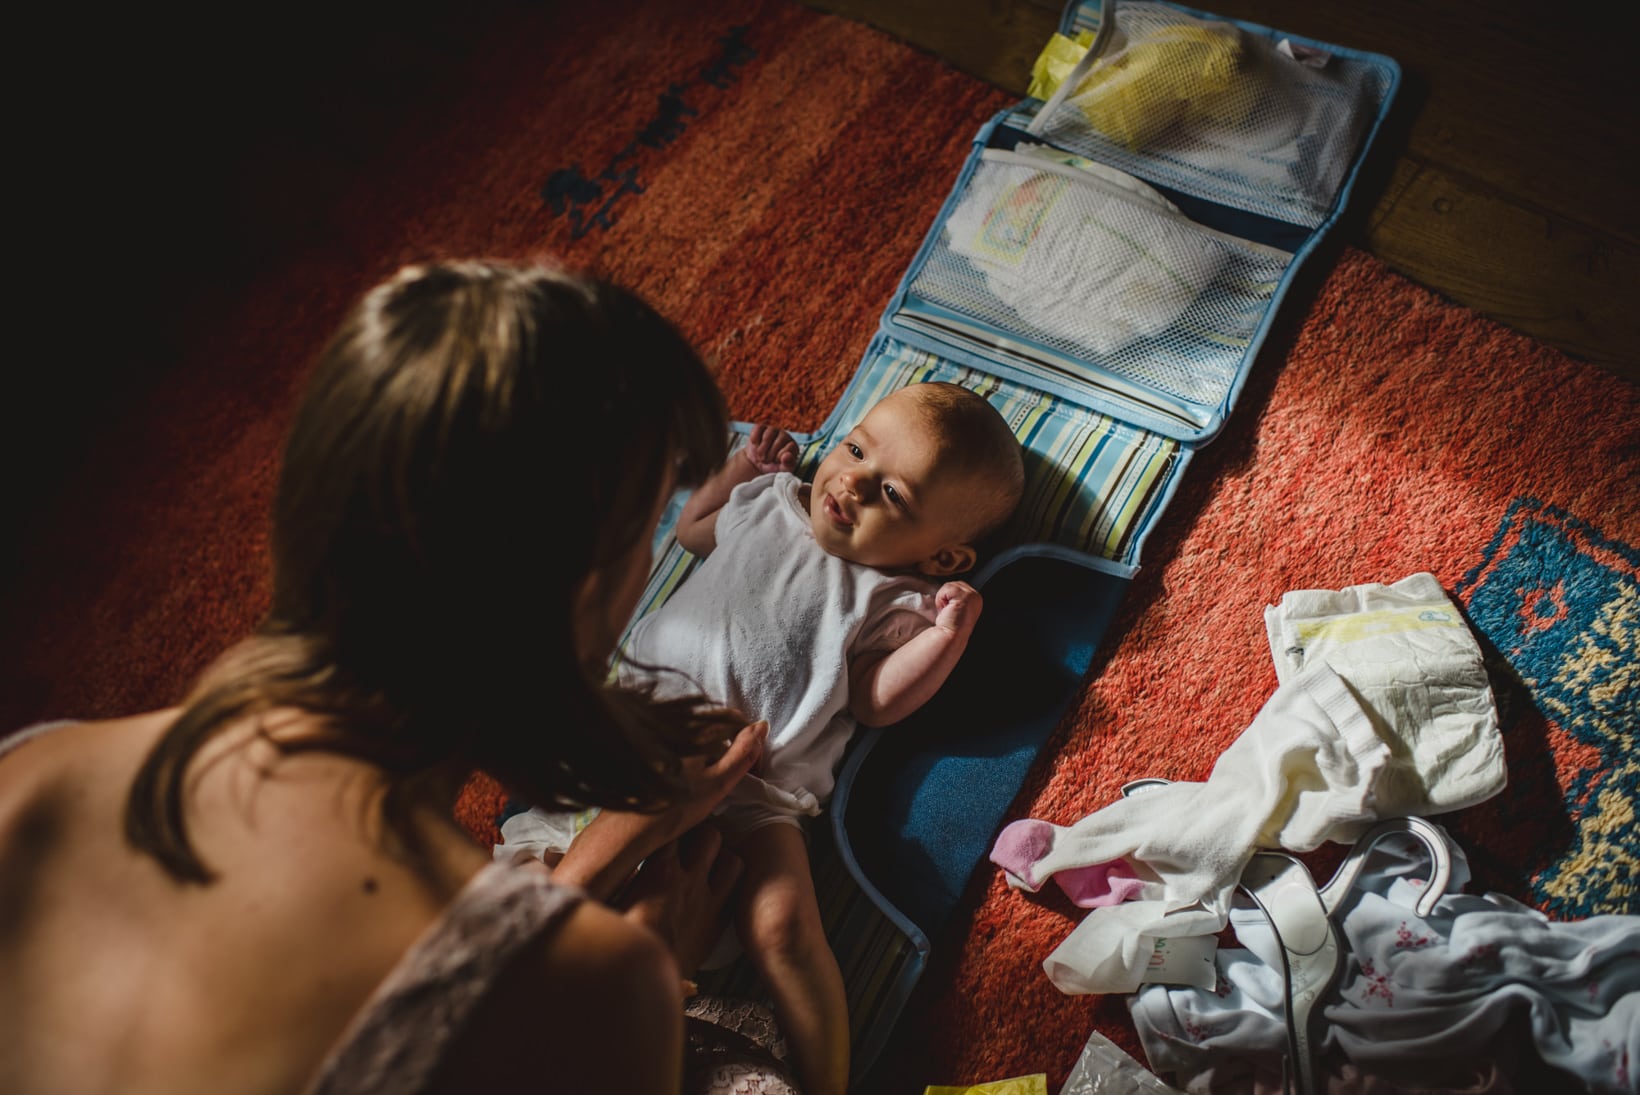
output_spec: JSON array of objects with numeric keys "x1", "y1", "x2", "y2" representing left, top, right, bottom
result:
[{"x1": 0, "y1": 711, "x2": 489, "y2": 1093}]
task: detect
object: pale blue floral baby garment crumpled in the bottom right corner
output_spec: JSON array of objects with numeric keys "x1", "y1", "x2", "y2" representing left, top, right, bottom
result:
[{"x1": 1128, "y1": 838, "x2": 1640, "y2": 1092}]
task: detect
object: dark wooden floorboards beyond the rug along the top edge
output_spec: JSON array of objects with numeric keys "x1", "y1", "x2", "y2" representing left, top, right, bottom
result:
[{"x1": 809, "y1": 0, "x2": 1640, "y2": 382}]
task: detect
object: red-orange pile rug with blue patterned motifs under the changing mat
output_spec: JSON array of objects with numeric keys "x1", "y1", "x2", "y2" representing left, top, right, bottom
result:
[{"x1": 0, "y1": 0, "x2": 1640, "y2": 1095}]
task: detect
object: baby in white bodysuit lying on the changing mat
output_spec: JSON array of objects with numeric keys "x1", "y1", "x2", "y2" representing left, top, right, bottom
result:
[{"x1": 618, "y1": 382, "x2": 1025, "y2": 1095}]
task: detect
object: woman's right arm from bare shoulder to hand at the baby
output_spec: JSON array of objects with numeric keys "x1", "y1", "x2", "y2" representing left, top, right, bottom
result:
[{"x1": 433, "y1": 723, "x2": 769, "y2": 1095}]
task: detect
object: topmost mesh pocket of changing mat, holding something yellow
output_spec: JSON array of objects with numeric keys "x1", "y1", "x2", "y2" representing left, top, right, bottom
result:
[{"x1": 1032, "y1": 0, "x2": 1389, "y2": 228}]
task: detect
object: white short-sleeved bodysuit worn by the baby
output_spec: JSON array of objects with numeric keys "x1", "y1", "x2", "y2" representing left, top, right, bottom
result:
[{"x1": 618, "y1": 472, "x2": 936, "y2": 815}]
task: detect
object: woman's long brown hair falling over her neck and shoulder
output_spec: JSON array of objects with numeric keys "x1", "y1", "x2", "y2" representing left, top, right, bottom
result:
[{"x1": 125, "y1": 261, "x2": 730, "y2": 882}]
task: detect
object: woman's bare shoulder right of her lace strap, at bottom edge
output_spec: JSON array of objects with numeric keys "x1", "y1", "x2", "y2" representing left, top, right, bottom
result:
[{"x1": 435, "y1": 902, "x2": 684, "y2": 1095}]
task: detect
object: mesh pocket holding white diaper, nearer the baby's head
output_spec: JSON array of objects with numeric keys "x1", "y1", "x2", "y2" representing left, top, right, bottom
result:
[{"x1": 907, "y1": 149, "x2": 1291, "y2": 428}]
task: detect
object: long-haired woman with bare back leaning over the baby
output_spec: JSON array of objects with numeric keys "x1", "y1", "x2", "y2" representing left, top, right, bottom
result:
[{"x1": 0, "y1": 262, "x2": 780, "y2": 1095}]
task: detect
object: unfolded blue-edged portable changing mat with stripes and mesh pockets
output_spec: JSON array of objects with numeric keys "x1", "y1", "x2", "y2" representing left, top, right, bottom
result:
[{"x1": 636, "y1": 0, "x2": 1401, "y2": 1082}]
